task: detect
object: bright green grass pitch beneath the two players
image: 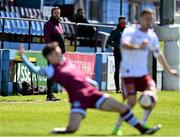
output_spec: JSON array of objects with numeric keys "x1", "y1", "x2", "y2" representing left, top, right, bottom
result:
[{"x1": 0, "y1": 92, "x2": 180, "y2": 136}]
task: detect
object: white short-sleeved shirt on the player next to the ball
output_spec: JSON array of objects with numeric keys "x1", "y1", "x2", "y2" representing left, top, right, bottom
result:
[{"x1": 121, "y1": 25, "x2": 160, "y2": 77}]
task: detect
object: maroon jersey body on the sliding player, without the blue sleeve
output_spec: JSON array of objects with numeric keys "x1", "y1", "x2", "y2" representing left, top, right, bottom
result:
[{"x1": 52, "y1": 61, "x2": 102, "y2": 102}]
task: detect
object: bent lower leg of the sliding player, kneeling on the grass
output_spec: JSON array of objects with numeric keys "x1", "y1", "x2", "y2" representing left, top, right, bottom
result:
[{"x1": 51, "y1": 113, "x2": 84, "y2": 134}]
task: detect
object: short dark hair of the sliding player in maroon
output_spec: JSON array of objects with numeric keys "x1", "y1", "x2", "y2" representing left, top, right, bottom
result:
[{"x1": 42, "y1": 42, "x2": 58, "y2": 58}]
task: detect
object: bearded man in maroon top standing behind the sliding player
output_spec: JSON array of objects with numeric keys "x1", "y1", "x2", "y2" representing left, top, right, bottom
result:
[{"x1": 44, "y1": 7, "x2": 65, "y2": 101}]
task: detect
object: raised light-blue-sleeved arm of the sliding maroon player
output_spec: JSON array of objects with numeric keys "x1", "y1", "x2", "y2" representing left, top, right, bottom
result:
[{"x1": 19, "y1": 47, "x2": 54, "y2": 78}]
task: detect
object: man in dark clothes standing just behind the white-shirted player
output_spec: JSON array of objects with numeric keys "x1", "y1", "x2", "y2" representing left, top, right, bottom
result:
[{"x1": 107, "y1": 16, "x2": 126, "y2": 93}]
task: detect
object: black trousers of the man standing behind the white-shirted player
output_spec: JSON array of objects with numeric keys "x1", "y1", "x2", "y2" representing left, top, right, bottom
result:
[{"x1": 113, "y1": 48, "x2": 121, "y2": 92}]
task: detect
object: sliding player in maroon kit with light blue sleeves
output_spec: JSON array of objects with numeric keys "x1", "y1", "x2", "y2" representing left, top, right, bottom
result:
[{"x1": 19, "y1": 42, "x2": 160, "y2": 134}]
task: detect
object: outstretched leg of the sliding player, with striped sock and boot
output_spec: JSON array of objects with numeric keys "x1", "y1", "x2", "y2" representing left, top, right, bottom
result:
[{"x1": 99, "y1": 97, "x2": 160, "y2": 134}]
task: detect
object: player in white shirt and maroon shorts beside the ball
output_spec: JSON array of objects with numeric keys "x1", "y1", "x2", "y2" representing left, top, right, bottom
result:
[{"x1": 113, "y1": 9, "x2": 179, "y2": 135}]
